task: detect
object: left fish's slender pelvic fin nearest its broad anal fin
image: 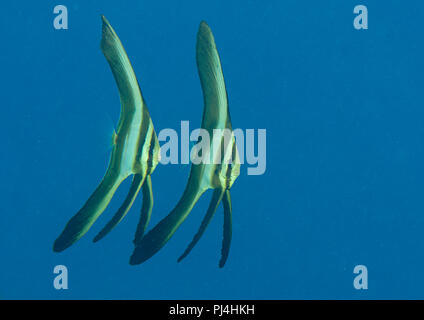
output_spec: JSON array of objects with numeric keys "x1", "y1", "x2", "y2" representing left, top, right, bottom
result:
[{"x1": 93, "y1": 174, "x2": 144, "y2": 242}]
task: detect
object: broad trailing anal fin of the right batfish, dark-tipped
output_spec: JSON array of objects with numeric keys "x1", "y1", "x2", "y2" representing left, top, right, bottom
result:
[{"x1": 130, "y1": 179, "x2": 206, "y2": 265}]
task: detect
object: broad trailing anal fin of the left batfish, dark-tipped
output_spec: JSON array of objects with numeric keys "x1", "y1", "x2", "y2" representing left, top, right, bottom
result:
[{"x1": 53, "y1": 171, "x2": 125, "y2": 252}]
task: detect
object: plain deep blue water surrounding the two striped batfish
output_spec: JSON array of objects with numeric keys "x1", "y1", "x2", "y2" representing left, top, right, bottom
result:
[{"x1": 0, "y1": 0, "x2": 424, "y2": 299}]
